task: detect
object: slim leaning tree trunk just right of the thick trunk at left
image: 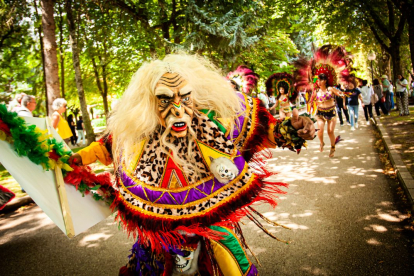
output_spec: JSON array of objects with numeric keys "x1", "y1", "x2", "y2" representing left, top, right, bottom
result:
[{"x1": 65, "y1": 0, "x2": 95, "y2": 144}]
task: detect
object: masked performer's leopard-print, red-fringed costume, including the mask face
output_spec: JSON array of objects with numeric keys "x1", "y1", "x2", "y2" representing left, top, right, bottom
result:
[{"x1": 74, "y1": 55, "x2": 312, "y2": 276}]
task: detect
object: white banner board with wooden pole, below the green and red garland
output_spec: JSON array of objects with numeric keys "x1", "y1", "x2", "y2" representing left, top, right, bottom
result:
[{"x1": 0, "y1": 117, "x2": 111, "y2": 237}]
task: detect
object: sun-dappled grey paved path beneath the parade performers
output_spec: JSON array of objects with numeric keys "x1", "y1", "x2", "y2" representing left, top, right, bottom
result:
[{"x1": 0, "y1": 107, "x2": 414, "y2": 275}]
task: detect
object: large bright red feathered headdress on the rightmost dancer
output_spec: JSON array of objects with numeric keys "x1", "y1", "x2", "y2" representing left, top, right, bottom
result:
[{"x1": 294, "y1": 45, "x2": 352, "y2": 112}]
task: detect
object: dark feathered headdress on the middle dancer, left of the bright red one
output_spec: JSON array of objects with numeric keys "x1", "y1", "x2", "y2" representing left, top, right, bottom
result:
[{"x1": 265, "y1": 73, "x2": 298, "y2": 103}]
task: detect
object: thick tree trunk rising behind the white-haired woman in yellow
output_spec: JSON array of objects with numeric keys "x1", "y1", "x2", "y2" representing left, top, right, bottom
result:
[{"x1": 41, "y1": 0, "x2": 60, "y2": 116}]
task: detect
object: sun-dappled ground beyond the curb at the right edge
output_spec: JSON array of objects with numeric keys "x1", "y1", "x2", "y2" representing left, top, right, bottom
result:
[{"x1": 380, "y1": 106, "x2": 414, "y2": 177}]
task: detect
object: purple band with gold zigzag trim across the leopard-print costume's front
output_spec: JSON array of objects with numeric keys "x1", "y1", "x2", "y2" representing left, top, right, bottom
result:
[{"x1": 121, "y1": 152, "x2": 246, "y2": 205}]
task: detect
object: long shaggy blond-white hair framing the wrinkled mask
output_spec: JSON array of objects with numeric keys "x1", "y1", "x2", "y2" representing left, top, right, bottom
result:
[{"x1": 106, "y1": 54, "x2": 246, "y2": 172}]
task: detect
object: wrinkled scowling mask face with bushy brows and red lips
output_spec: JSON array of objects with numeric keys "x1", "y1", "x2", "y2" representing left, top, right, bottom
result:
[{"x1": 155, "y1": 73, "x2": 194, "y2": 138}]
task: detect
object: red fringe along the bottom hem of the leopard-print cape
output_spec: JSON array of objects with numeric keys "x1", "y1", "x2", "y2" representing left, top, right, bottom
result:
[{"x1": 112, "y1": 169, "x2": 287, "y2": 252}]
